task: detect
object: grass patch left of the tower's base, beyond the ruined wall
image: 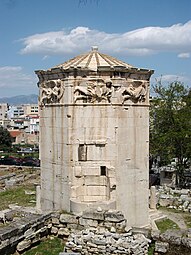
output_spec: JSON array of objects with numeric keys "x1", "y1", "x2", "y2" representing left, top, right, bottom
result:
[{"x1": 0, "y1": 185, "x2": 36, "y2": 210}]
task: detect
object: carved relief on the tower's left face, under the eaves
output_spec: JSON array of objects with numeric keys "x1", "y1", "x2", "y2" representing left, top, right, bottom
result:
[{"x1": 39, "y1": 80, "x2": 64, "y2": 107}]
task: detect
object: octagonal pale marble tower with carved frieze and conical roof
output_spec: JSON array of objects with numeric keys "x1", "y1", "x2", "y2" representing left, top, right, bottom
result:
[{"x1": 36, "y1": 47, "x2": 153, "y2": 227}]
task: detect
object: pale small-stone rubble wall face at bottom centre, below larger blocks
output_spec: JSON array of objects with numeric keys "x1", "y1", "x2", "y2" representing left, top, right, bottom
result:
[{"x1": 65, "y1": 229, "x2": 150, "y2": 255}]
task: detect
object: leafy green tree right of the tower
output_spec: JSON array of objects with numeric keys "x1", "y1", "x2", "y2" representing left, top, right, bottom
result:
[{"x1": 150, "y1": 81, "x2": 191, "y2": 185}]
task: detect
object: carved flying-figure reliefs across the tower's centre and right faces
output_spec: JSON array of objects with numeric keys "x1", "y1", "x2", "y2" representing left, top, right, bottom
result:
[{"x1": 74, "y1": 80, "x2": 149, "y2": 104}]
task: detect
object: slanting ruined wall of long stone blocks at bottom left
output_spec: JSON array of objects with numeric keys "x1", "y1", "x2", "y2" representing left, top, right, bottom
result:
[{"x1": 0, "y1": 211, "x2": 51, "y2": 255}]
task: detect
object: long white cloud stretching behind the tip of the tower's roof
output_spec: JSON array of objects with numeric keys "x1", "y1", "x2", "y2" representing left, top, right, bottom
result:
[{"x1": 20, "y1": 21, "x2": 191, "y2": 57}]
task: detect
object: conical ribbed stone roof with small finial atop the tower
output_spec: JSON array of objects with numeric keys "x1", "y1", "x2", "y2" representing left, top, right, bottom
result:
[{"x1": 54, "y1": 46, "x2": 134, "y2": 71}]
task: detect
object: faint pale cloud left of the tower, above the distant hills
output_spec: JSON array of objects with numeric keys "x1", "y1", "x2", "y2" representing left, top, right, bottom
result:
[{"x1": 0, "y1": 66, "x2": 37, "y2": 89}]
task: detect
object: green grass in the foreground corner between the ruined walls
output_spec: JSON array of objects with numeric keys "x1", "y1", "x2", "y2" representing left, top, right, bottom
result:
[{"x1": 23, "y1": 237, "x2": 64, "y2": 255}]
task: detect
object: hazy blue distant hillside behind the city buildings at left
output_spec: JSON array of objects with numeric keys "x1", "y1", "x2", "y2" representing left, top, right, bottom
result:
[{"x1": 0, "y1": 94, "x2": 38, "y2": 105}]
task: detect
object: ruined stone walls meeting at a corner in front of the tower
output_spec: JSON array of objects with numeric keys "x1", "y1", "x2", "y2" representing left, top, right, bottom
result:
[{"x1": 0, "y1": 209, "x2": 150, "y2": 255}]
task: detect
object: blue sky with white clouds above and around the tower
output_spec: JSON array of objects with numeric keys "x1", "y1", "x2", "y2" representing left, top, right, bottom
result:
[{"x1": 0, "y1": 0, "x2": 191, "y2": 98}]
